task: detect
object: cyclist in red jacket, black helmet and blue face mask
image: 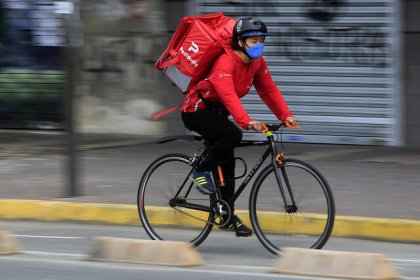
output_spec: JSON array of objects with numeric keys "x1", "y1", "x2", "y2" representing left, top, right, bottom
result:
[{"x1": 181, "y1": 17, "x2": 298, "y2": 236}]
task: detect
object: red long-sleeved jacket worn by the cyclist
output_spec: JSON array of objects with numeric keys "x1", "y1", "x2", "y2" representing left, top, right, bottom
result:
[{"x1": 181, "y1": 52, "x2": 292, "y2": 129}]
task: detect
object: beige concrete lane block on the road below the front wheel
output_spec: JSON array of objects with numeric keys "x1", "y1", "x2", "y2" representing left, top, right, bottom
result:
[{"x1": 272, "y1": 247, "x2": 399, "y2": 280}]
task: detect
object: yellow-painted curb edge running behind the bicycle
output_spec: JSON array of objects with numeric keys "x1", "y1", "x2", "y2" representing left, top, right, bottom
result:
[{"x1": 0, "y1": 199, "x2": 420, "y2": 243}]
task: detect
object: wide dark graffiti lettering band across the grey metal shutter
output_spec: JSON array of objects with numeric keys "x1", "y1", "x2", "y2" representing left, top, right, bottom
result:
[{"x1": 279, "y1": 26, "x2": 388, "y2": 67}]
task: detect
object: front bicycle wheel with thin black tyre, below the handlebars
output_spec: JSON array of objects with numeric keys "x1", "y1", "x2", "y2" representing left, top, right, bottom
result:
[{"x1": 249, "y1": 159, "x2": 335, "y2": 254}]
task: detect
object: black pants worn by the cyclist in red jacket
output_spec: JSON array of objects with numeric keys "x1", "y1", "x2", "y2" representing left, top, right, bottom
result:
[{"x1": 181, "y1": 109, "x2": 242, "y2": 210}]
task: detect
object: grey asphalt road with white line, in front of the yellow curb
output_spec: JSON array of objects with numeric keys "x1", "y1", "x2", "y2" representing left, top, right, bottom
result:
[{"x1": 0, "y1": 221, "x2": 420, "y2": 280}]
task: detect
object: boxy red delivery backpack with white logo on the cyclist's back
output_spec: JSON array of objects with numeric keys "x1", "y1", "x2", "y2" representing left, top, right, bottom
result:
[{"x1": 155, "y1": 12, "x2": 236, "y2": 94}]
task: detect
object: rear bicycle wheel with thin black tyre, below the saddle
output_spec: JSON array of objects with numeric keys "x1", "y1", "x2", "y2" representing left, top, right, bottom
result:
[{"x1": 137, "y1": 154, "x2": 212, "y2": 246}]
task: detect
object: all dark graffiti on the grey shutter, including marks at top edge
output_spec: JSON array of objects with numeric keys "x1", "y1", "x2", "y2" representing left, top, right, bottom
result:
[{"x1": 225, "y1": 0, "x2": 390, "y2": 67}]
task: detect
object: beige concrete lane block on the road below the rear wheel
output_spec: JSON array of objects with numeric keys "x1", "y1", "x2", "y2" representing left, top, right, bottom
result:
[{"x1": 89, "y1": 237, "x2": 203, "y2": 266}]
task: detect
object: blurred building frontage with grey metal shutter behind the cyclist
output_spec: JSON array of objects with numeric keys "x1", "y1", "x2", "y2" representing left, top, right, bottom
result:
[{"x1": 0, "y1": 0, "x2": 420, "y2": 147}]
